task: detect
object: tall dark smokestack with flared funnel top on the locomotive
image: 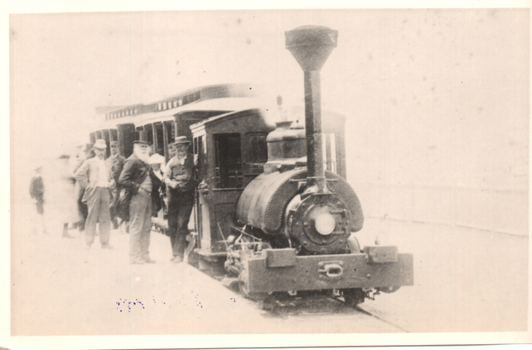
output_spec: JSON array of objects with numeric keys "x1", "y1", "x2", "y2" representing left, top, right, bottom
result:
[{"x1": 285, "y1": 26, "x2": 338, "y2": 193}]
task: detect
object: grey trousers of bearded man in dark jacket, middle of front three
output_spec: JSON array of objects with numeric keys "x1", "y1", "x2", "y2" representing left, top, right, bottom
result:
[{"x1": 129, "y1": 189, "x2": 151, "y2": 260}]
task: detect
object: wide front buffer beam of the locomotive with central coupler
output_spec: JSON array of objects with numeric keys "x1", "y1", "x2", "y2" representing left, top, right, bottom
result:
[{"x1": 239, "y1": 246, "x2": 414, "y2": 295}]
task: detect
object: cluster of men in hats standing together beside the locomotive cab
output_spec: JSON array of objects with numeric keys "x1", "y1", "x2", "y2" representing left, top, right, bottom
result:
[{"x1": 75, "y1": 136, "x2": 197, "y2": 264}]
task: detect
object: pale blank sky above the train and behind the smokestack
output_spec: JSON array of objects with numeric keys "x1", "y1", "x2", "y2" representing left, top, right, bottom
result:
[{"x1": 10, "y1": 9, "x2": 529, "y2": 191}]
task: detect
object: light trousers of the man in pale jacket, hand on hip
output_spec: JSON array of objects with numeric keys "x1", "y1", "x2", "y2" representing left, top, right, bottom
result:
[{"x1": 85, "y1": 187, "x2": 111, "y2": 245}]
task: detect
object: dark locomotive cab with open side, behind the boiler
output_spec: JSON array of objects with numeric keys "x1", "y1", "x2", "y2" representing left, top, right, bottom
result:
[{"x1": 189, "y1": 109, "x2": 273, "y2": 270}]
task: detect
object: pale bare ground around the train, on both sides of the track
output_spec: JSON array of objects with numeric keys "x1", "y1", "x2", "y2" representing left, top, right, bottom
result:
[{"x1": 7, "y1": 200, "x2": 528, "y2": 342}]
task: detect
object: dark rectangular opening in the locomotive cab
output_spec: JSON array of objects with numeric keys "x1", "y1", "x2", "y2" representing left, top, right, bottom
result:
[{"x1": 213, "y1": 134, "x2": 242, "y2": 188}]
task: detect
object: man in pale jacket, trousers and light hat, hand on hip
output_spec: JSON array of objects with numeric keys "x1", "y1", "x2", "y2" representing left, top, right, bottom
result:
[{"x1": 75, "y1": 139, "x2": 113, "y2": 249}]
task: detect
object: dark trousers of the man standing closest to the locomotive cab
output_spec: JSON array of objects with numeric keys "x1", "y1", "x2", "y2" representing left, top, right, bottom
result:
[{"x1": 168, "y1": 189, "x2": 194, "y2": 258}]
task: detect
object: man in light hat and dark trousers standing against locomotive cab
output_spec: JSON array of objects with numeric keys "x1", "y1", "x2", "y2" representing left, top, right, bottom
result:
[{"x1": 165, "y1": 136, "x2": 196, "y2": 263}]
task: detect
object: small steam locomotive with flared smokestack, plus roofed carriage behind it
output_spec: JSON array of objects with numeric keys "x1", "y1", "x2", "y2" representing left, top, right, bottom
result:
[{"x1": 91, "y1": 26, "x2": 413, "y2": 306}]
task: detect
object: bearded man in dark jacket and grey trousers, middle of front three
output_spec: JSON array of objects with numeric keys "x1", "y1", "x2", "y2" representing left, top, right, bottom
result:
[{"x1": 118, "y1": 133, "x2": 155, "y2": 264}]
